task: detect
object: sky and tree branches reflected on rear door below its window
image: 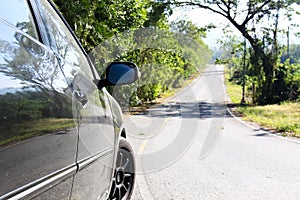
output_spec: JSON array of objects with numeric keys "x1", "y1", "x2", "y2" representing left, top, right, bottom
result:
[{"x1": 0, "y1": 21, "x2": 68, "y2": 115}]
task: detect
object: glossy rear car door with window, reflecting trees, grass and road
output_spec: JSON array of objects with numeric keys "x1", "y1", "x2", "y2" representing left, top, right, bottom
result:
[{"x1": 0, "y1": 0, "x2": 78, "y2": 199}]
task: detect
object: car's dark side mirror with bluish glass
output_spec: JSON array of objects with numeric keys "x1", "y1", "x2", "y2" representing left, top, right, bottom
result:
[{"x1": 98, "y1": 62, "x2": 140, "y2": 89}]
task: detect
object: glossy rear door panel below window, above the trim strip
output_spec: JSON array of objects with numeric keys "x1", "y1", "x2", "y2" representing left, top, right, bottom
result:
[{"x1": 0, "y1": 19, "x2": 77, "y2": 199}]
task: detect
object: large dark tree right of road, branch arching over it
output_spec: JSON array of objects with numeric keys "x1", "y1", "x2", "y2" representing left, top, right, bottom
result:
[{"x1": 170, "y1": 0, "x2": 300, "y2": 104}]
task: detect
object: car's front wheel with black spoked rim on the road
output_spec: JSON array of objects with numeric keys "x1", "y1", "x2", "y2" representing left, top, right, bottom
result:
[{"x1": 109, "y1": 138, "x2": 135, "y2": 200}]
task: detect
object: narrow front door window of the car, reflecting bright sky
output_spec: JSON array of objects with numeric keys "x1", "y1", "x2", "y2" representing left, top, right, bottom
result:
[{"x1": 41, "y1": 1, "x2": 92, "y2": 78}]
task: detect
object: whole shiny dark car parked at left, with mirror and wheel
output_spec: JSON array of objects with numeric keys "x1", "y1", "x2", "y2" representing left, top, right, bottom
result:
[{"x1": 0, "y1": 0, "x2": 138, "y2": 199}]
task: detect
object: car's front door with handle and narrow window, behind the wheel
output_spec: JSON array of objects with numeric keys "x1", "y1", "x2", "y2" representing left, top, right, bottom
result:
[{"x1": 36, "y1": 0, "x2": 117, "y2": 199}]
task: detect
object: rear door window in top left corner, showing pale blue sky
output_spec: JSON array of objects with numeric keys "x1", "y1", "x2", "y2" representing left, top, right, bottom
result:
[{"x1": 0, "y1": 0, "x2": 38, "y2": 39}]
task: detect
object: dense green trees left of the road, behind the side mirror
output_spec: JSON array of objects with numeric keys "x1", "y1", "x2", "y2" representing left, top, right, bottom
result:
[{"x1": 55, "y1": 0, "x2": 211, "y2": 106}]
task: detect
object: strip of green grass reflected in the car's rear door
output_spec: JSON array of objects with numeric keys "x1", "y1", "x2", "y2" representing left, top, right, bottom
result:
[{"x1": 0, "y1": 118, "x2": 74, "y2": 146}]
